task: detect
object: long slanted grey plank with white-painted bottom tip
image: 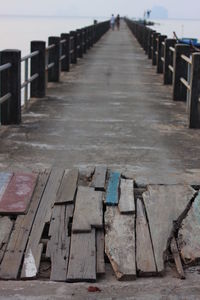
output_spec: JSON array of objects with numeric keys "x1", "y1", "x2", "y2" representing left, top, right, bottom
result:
[{"x1": 21, "y1": 168, "x2": 64, "y2": 278}]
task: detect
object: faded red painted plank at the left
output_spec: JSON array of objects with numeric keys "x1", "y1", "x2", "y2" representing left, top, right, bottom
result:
[{"x1": 0, "y1": 173, "x2": 37, "y2": 214}]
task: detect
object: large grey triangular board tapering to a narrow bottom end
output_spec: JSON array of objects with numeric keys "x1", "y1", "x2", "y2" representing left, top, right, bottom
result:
[{"x1": 143, "y1": 185, "x2": 195, "y2": 272}]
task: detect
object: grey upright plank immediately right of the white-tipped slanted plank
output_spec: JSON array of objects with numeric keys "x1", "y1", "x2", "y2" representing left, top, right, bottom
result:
[{"x1": 47, "y1": 204, "x2": 73, "y2": 281}]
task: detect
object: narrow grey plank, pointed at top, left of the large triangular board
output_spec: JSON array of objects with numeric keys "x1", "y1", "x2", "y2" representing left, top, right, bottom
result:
[{"x1": 136, "y1": 199, "x2": 156, "y2": 276}]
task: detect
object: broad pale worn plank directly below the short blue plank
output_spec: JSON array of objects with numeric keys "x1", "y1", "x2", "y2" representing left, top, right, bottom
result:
[{"x1": 105, "y1": 207, "x2": 136, "y2": 280}]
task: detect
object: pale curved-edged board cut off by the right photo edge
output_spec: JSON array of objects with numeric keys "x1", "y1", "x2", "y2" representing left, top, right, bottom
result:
[{"x1": 177, "y1": 193, "x2": 200, "y2": 264}]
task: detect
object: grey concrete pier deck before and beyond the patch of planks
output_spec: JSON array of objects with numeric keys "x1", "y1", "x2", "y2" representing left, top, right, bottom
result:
[{"x1": 0, "y1": 21, "x2": 200, "y2": 300}]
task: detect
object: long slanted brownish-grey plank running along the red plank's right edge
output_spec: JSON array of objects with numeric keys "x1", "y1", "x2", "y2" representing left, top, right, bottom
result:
[{"x1": 0, "y1": 172, "x2": 49, "y2": 279}]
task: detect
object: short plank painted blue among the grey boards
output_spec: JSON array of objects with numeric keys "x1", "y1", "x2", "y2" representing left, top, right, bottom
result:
[{"x1": 106, "y1": 172, "x2": 120, "y2": 205}]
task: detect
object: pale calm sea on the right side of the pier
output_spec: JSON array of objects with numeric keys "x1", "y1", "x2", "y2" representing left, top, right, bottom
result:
[{"x1": 152, "y1": 19, "x2": 200, "y2": 40}]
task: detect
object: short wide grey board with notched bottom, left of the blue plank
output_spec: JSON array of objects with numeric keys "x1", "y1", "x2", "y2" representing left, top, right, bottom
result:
[{"x1": 72, "y1": 186, "x2": 103, "y2": 233}]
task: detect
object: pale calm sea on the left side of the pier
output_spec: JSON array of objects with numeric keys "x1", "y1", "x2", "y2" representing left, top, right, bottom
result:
[{"x1": 0, "y1": 16, "x2": 101, "y2": 55}]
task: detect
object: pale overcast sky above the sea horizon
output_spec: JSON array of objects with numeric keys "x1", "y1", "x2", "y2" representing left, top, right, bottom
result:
[{"x1": 0, "y1": 0, "x2": 200, "y2": 19}]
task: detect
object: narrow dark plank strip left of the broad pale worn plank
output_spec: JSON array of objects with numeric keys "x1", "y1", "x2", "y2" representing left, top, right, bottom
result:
[{"x1": 96, "y1": 229, "x2": 105, "y2": 275}]
